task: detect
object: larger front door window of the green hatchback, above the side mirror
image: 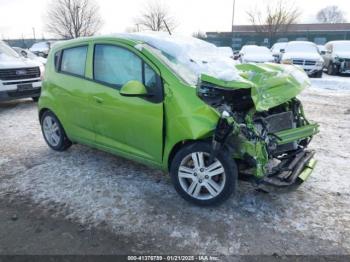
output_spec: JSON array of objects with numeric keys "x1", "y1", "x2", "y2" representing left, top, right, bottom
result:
[{"x1": 94, "y1": 45, "x2": 143, "y2": 88}]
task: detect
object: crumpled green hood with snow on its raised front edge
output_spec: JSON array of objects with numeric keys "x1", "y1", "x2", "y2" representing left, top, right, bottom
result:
[{"x1": 201, "y1": 63, "x2": 311, "y2": 111}]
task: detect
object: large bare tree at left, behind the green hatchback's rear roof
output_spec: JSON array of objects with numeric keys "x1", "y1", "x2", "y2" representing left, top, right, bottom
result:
[{"x1": 46, "y1": 0, "x2": 102, "y2": 39}]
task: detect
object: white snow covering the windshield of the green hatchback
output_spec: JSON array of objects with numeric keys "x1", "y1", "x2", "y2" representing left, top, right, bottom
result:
[{"x1": 117, "y1": 33, "x2": 241, "y2": 85}]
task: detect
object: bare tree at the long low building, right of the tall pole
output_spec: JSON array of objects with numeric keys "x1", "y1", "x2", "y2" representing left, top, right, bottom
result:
[{"x1": 247, "y1": 0, "x2": 301, "y2": 39}]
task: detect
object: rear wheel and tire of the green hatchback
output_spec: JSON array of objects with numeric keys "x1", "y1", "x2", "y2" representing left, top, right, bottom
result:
[{"x1": 40, "y1": 111, "x2": 72, "y2": 151}]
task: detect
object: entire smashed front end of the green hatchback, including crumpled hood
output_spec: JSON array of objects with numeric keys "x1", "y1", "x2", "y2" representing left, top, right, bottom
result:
[{"x1": 198, "y1": 64, "x2": 318, "y2": 187}]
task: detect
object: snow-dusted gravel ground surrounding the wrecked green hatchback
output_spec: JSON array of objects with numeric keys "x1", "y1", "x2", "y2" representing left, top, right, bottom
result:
[{"x1": 0, "y1": 75, "x2": 350, "y2": 255}]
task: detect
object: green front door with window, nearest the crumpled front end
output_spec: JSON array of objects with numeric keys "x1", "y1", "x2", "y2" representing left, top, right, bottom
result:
[{"x1": 90, "y1": 42, "x2": 163, "y2": 163}]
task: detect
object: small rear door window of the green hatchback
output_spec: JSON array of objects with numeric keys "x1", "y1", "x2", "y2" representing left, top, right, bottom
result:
[{"x1": 60, "y1": 46, "x2": 88, "y2": 76}]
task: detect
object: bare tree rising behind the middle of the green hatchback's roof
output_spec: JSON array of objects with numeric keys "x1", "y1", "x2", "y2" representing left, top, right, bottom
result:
[{"x1": 135, "y1": 1, "x2": 177, "y2": 33}]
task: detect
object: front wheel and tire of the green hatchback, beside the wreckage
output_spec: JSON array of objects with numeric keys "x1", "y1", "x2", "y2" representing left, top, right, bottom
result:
[{"x1": 170, "y1": 142, "x2": 238, "y2": 206}]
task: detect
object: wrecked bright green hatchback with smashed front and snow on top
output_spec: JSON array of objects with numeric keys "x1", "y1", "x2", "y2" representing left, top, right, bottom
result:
[{"x1": 39, "y1": 34, "x2": 318, "y2": 205}]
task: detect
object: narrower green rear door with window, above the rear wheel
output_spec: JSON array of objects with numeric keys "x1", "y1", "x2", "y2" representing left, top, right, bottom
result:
[{"x1": 52, "y1": 43, "x2": 95, "y2": 143}]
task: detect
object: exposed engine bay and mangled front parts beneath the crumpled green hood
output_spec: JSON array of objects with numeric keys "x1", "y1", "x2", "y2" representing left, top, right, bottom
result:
[{"x1": 197, "y1": 82, "x2": 317, "y2": 186}]
